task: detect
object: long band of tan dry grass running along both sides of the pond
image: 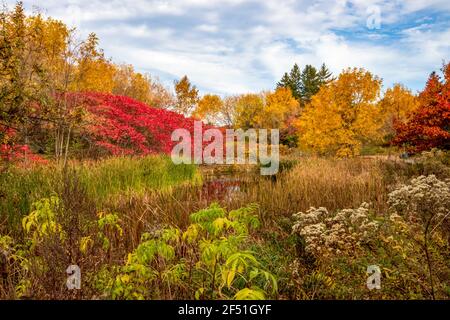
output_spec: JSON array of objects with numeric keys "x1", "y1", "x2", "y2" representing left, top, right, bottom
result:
[{"x1": 108, "y1": 158, "x2": 389, "y2": 243}]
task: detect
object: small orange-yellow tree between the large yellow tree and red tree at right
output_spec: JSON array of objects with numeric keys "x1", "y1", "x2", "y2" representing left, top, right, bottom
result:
[{"x1": 380, "y1": 83, "x2": 418, "y2": 141}]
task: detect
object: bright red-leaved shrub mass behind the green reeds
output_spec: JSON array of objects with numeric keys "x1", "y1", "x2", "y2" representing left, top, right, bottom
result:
[{"x1": 69, "y1": 93, "x2": 214, "y2": 155}]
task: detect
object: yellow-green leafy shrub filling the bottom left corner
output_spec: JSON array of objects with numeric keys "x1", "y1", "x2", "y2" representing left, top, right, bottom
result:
[{"x1": 0, "y1": 186, "x2": 123, "y2": 299}]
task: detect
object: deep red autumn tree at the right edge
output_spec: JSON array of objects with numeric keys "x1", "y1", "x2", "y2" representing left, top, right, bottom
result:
[{"x1": 393, "y1": 63, "x2": 450, "y2": 153}]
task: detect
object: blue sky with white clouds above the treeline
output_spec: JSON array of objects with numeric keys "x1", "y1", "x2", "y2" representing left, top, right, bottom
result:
[{"x1": 7, "y1": 0, "x2": 450, "y2": 95}]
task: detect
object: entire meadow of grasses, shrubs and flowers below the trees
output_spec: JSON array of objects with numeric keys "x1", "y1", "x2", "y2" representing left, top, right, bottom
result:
[{"x1": 0, "y1": 152, "x2": 450, "y2": 299}]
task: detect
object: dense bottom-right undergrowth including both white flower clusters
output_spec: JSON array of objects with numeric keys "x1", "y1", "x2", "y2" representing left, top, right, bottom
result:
[{"x1": 292, "y1": 176, "x2": 450, "y2": 299}]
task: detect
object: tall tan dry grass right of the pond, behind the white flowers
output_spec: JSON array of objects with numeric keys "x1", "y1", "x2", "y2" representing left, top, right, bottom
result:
[{"x1": 237, "y1": 158, "x2": 387, "y2": 216}]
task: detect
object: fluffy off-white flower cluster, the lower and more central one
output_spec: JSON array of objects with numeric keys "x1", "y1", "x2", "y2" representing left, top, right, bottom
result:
[{"x1": 292, "y1": 203, "x2": 378, "y2": 256}]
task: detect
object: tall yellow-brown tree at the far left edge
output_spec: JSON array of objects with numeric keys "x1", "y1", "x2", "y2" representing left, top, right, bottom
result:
[{"x1": 0, "y1": 2, "x2": 56, "y2": 164}]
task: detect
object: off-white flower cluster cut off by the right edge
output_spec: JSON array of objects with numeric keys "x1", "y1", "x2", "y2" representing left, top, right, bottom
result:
[{"x1": 388, "y1": 175, "x2": 450, "y2": 219}]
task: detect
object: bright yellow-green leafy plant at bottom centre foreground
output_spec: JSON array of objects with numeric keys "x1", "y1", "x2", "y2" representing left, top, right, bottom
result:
[{"x1": 98, "y1": 204, "x2": 278, "y2": 299}]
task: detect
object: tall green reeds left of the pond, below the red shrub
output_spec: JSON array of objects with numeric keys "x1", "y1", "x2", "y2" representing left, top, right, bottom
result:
[{"x1": 0, "y1": 156, "x2": 201, "y2": 225}]
